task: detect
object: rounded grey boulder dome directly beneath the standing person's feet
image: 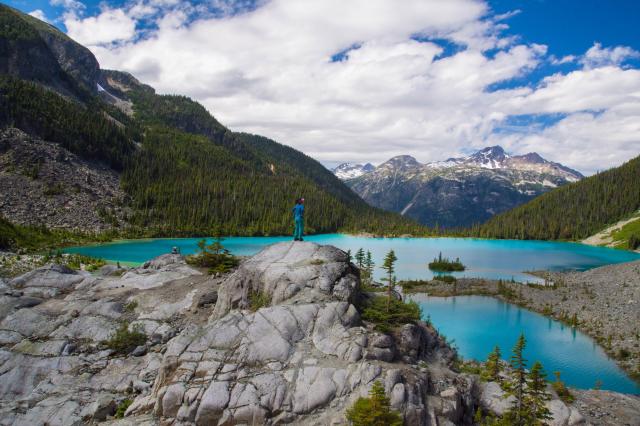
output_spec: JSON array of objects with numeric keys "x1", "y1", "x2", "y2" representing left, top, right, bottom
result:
[{"x1": 212, "y1": 242, "x2": 358, "y2": 318}]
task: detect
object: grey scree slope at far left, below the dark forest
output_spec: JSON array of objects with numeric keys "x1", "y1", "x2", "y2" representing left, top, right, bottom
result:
[{"x1": 0, "y1": 128, "x2": 128, "y2": 232}]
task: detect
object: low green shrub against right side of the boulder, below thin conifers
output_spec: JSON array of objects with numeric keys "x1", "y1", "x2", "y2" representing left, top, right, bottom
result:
[{"x1": 362, "y1": 296, "x2": 421, "y2": 332}]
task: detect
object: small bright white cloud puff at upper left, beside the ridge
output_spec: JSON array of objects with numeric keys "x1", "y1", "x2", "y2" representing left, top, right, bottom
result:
[{"x1": 64, "y1": 9, "x2": 136, "y2": 46}]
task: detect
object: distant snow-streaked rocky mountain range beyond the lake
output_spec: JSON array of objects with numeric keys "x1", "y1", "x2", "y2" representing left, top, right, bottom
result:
[{"x1": 333, "y1": 146, "x2": 584, "y2": 228}]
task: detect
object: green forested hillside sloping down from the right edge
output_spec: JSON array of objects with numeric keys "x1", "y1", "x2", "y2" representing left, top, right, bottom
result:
[{"x1": 472, "y1": 157, "x2": 640, "y2": 240}]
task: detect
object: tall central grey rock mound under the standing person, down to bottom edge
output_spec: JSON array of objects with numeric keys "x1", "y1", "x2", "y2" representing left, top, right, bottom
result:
[{"x1": 141, "y1": 243, "x2": 472, "y2": 425}]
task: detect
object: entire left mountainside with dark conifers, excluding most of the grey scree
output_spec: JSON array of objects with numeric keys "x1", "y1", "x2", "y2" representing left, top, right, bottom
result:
[{"x1": 0, "y1": 5, "x2": 429, "y2": 240}]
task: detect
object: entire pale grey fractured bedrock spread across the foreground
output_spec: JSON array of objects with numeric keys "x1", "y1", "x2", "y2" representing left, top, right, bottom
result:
[{"x1": 0, "y1": 243, "x2": 640, "y2": 425}]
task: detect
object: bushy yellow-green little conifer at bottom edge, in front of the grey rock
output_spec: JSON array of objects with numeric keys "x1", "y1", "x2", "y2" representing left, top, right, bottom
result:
[{"x1": 347, "y1": 381, "x2": 403, "y2": 426}]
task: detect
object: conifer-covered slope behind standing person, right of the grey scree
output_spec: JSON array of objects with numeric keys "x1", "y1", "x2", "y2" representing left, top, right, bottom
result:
[{"x1": 114, "y1": 71, "x2": 426, "y2": 235}]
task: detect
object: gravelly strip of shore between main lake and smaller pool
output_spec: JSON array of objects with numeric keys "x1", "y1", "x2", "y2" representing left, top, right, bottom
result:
[{"x1": 404, "y1": 268, "x2": 640, "y2": 383}]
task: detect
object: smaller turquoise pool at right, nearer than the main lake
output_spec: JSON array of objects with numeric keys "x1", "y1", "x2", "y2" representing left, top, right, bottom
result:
[{"x1": 411, "y1": 294, "x2": 640, "y2": 394}]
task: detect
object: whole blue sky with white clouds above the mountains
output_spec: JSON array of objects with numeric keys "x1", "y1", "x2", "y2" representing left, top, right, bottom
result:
[{"x1": 8, "y1": 0, "x2": 640, "y2": 174}]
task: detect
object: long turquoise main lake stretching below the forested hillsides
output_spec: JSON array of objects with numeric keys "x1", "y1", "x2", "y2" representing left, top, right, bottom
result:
[{"x1": 65, "y1": 234, "x2": 640, "y2": 282}]
